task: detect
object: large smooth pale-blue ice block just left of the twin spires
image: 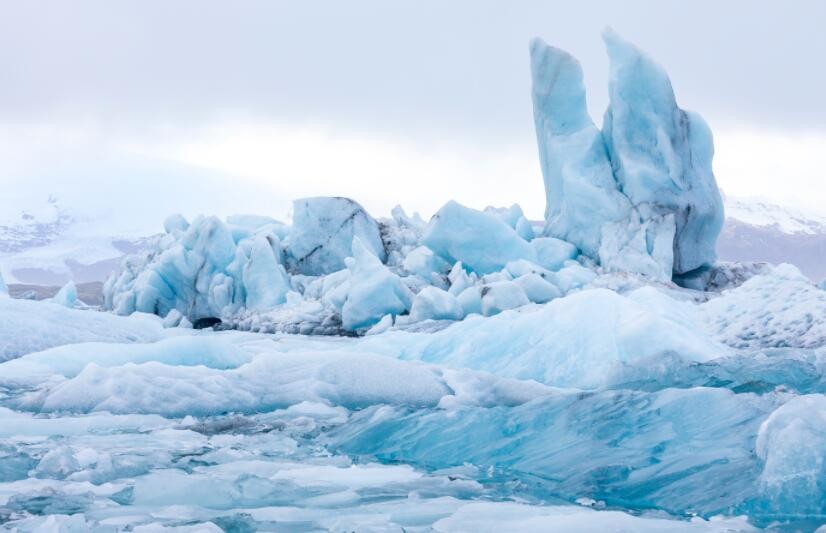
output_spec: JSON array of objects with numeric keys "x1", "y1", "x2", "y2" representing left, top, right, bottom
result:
[{"x1": 422, "y1": 201, "x2": 535, "y2": 274}]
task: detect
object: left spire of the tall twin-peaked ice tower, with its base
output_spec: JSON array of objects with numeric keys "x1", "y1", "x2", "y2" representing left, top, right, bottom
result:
[{"x1": 531, "y1": 39, "x2": 674, "y2": 281}]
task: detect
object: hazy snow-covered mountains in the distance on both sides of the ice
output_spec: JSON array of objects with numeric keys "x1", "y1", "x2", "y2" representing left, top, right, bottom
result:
[{"x1": 0, "y1": 197, "x2": 826, "y2": 286}]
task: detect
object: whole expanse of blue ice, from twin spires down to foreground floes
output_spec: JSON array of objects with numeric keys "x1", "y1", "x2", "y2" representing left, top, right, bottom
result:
[{"x1": 0, "y1": 30, "x2": 826, "y2": 532}]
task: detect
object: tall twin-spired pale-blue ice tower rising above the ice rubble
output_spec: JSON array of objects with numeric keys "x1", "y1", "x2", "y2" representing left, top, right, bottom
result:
[{"x1": 531, "y1": 30, "x2": 723, "y2": 280}]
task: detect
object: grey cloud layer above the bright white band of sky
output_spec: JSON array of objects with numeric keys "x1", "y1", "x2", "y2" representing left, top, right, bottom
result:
[{"x1": 0, "y1": 0, "x2": 826, "y2": 142}]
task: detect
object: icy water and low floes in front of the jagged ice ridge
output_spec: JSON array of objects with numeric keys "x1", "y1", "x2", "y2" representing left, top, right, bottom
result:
[{"x1": 0, "y1": 291, "x2": 826, "y2": 531}]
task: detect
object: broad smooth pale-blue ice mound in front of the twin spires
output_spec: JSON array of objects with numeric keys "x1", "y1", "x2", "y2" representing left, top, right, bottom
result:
[{"x1": 404, "y1": 282, "x2": 731, "y2": 389}]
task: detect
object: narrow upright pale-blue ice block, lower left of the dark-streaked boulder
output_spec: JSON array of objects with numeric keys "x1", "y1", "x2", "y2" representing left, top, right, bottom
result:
[{"x1": 243, "y1": 235, "x2": 290, "y2": 311}]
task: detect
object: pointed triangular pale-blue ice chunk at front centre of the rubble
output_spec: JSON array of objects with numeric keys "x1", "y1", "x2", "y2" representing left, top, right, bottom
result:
[{"x1": 341, "y1": 237, "x2": 412, "y2": 331}]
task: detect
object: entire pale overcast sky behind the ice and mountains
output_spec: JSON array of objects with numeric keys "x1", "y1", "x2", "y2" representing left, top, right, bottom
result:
[{"x1": 0, "y1": 0, "x2": 826, "y2": 229}]
